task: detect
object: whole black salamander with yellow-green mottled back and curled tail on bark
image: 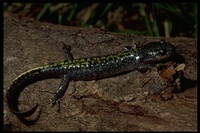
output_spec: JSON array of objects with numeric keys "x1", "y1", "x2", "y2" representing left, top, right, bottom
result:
[{"x1": 6, "y1": 40, "x2": 175, "y2": 122}]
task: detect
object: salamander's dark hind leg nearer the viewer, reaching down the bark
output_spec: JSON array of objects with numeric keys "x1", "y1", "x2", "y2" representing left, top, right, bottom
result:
[{"x1": 52, "y1": 75, "x2": 70, "y2": 112}]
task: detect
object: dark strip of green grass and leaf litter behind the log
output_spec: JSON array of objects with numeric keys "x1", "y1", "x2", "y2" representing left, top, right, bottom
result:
[{"x1": 4, "y1": 2, "x2": 197, "y2": 38}]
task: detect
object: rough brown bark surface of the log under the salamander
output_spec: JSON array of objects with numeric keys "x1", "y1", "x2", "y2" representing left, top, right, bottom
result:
[{"x1": 3, "y1": 13, "x2": 197, "y2": 131}]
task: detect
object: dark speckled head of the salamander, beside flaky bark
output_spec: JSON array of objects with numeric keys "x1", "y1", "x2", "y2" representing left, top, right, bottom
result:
[{"x1": 139, "y1": 40, "x2": 175, "y2": 63}]
